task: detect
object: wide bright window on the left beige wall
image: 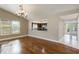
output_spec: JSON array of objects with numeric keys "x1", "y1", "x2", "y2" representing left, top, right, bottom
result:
[{"x1": 0, "y1": 19, "x2": 20, "y2": 35}]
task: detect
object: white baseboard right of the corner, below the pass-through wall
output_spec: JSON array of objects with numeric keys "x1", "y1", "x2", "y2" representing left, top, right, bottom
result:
[{"x1": 28, "y1": 34, "x2": 79, "y2": 49}]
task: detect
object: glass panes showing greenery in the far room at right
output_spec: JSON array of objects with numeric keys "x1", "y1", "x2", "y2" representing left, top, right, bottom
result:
[{"x1": 65, "y1": 20, "x2": 77, "y2": 34}]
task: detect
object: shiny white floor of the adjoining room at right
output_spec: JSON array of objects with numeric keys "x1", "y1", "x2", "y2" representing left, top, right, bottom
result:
[{"x1": 59, "y1": 35, "x2": 79, "y2": 49}]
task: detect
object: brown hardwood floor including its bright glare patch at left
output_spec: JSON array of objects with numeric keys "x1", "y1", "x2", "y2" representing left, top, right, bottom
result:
[{"x1": 0, "y1": 36, "x2": 79, "y2": 54}]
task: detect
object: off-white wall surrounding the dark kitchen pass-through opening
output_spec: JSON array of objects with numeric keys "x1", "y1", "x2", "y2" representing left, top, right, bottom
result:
[{"x1": 29, "y1": 16, "x2": 58, "y2": 40}]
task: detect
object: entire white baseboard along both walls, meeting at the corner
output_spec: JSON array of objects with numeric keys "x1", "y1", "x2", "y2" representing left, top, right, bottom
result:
[{"x1": 0, "y1": 34, "x2": 79, "y2": 49}]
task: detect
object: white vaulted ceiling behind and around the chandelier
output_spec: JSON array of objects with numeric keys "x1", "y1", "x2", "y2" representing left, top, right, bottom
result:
[{"x1": 0, "y1": 4, "x2": 79, "y2": 19}]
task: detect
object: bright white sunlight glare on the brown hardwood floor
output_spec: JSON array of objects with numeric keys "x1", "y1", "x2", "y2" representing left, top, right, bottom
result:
[{"x1": 1, "y1": 40, "x2": 21, "y2": 54}]
